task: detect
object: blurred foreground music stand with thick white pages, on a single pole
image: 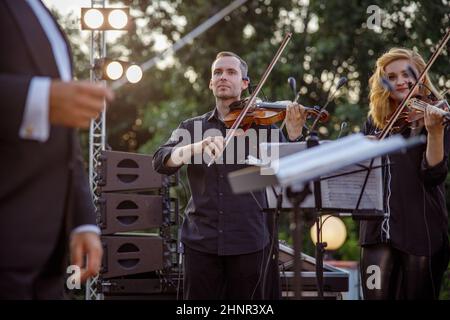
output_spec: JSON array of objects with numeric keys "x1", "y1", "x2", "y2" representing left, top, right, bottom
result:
[{"x1": 228, "y1": 134, "x2": 425, "y2": 299}]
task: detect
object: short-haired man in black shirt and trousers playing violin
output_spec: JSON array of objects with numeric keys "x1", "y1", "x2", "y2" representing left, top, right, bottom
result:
[{"x1": 153, "y1": 52, "x2": 306, "y2": 300}]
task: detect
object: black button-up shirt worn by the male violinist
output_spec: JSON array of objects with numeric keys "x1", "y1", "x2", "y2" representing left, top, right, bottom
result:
[{"x1": 153, "y1": 109, "x2": 286, "y2": 255}]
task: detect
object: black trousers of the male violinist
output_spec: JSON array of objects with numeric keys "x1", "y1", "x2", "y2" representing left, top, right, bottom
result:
[{"x1": 183, "y1": 245, "x2": 278, "y2": 300}]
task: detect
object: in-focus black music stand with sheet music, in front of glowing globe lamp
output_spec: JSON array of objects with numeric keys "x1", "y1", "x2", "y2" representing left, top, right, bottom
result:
[{"x1": 266, "y1": 143, "x2": 385, "y2": 299}]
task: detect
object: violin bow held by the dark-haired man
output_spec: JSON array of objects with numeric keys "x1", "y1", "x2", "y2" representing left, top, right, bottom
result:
[{"x1": 208, "y1": 32, "x2": 292, "y2": 167}]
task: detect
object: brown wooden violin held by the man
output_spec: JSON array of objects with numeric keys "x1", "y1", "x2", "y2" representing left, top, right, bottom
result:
[{"x1": 223, "y1": 99, "x2": 330, "y2": 128}]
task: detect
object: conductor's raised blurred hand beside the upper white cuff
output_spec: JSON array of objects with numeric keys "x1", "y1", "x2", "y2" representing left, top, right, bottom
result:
[{"x1": 49, "y1": 80, "x2": 114, "y2": 128}]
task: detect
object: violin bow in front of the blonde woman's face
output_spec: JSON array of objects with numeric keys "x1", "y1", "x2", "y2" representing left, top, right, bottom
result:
[{"x1": 380, "y1": 28, "x2": 450, "y2": 140}]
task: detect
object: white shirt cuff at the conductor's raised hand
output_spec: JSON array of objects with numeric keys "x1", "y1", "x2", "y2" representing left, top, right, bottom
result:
[{"x1": 19, "y1": 77, "x2": 51, "y2": 142}]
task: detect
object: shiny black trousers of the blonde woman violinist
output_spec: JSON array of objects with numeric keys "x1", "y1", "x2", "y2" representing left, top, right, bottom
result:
[{"x1": 361, "y1": 244, "x2": 449, "y2": 300}]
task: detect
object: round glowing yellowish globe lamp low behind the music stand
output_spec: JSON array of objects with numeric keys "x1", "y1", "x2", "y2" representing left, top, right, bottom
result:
[{"x1": 311, "y1": 215, "x2": 347, "y2": 250}]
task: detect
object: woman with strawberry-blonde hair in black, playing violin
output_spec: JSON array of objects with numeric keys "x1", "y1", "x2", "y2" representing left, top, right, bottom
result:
[{"x1": 360, "y1": 48, "x2": 450, "y2": 299}]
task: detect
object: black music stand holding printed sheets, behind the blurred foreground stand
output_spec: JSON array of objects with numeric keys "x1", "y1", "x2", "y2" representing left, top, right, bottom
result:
[{"x1": 268, "y1": 135, "x2": 384, "y2": 299}]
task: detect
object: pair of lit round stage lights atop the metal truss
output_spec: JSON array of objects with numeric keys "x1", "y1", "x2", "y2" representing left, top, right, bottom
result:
[{"x1": 81, "y1": 8, "x2": 130, "y2": 30}]
